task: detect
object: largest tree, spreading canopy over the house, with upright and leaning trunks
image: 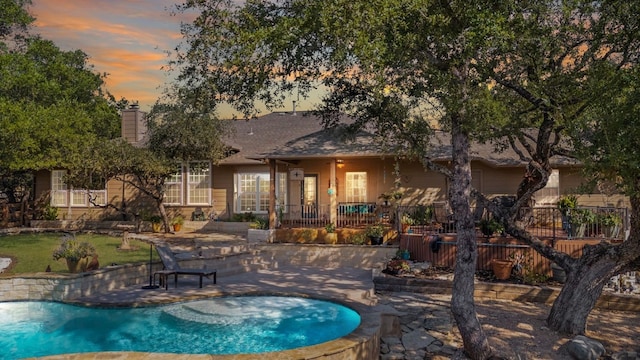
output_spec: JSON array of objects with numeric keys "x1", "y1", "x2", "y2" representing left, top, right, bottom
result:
[{"x1": 170, "y1": 0, "x2": 638, "y2": 359}]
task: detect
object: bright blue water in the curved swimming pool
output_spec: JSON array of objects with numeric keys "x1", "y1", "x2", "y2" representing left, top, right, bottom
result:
[{"x1": 0, "y1": 296, "x2": 360, "y2": 359}]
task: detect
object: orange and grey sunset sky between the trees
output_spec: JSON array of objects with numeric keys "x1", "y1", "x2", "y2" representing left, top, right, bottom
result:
[{"x1": 29, "y1": 0, "x2": 314, "y2": 117}]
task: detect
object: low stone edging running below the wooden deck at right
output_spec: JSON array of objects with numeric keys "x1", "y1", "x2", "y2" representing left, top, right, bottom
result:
[{"x1": 373, "y1": 273, "x2": 640, "y2": 312}]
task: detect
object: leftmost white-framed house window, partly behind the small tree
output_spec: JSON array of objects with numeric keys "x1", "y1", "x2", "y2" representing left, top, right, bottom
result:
[{"x1": 51, "y1": 170, "x2": 107, "y2": 207}]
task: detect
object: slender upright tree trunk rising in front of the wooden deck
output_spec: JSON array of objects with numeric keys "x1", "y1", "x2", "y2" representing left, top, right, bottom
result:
[{"x1": 449, "y1": 119, "x2": 492, "y2": 360}]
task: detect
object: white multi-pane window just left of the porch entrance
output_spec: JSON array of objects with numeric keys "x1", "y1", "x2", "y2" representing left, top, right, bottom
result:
[{"x1": 236, "y1": 173, "x2": 287, "y2": 213}]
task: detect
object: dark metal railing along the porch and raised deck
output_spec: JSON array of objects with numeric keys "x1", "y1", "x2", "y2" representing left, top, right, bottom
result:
[{"x1": 278, "y1": 202, "x2": 629, "y2": 240}]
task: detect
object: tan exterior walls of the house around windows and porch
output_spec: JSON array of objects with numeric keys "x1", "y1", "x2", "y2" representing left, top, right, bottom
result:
[{"x1": 30, "y1": 153, "x2": 629, "y2": 220}]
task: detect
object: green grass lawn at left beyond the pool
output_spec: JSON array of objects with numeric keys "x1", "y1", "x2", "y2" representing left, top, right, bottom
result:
[{"x1": 0, "y1": 233, "x2": 158, "y2": 274}]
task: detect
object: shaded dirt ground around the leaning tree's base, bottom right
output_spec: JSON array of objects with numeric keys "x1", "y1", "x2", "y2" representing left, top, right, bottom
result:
[{"x1": 468, "y1": 300, "x2": 640, "y2": 359}]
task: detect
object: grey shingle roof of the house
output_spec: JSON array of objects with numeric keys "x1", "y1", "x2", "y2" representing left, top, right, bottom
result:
[{"x1": 221, "y1": 112, "x2": 577, "y2": 167}]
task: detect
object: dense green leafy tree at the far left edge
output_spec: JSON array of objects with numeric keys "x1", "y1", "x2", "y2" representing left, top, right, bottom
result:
[{"x1": 0, "y1": 0, "x2": 122, "y2": 220}]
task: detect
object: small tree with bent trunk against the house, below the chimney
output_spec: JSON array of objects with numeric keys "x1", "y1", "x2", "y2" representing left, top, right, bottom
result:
[{"x1": 68, "y1": 101, "x2": 228, "y2": 232}]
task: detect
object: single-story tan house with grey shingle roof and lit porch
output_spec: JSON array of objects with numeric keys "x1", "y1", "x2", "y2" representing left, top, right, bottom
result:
[{"x1": 35, "y1": 106, "x2": 627, "y2": 226}]
